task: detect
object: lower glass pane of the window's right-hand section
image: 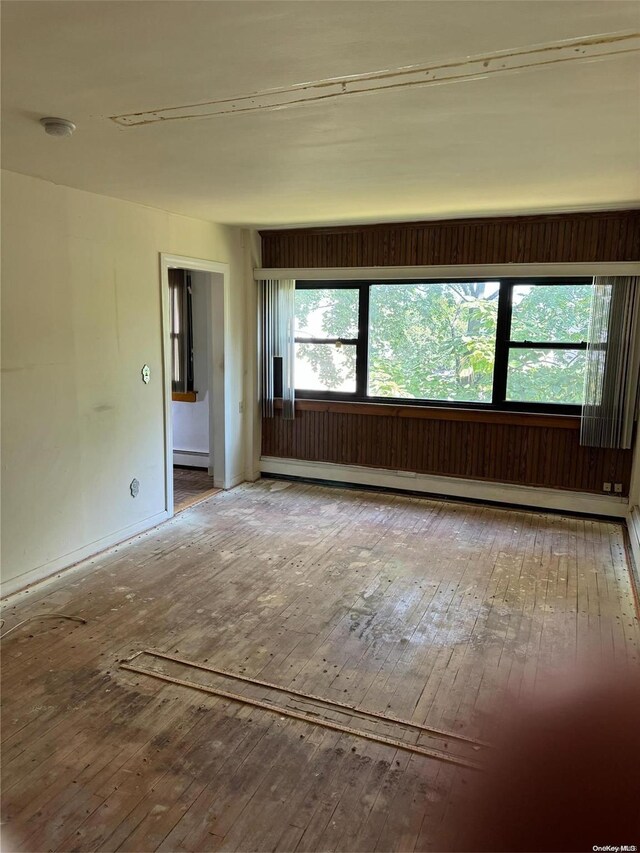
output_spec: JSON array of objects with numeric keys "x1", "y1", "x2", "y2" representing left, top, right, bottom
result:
[{"x1": 507, "y1": 349, "x2": 586, "y2": 406}]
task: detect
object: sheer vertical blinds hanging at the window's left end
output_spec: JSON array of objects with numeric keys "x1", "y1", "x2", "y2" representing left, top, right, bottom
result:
[{"x1": 260, "y1": 279, "x2": 296, "y2": 419}]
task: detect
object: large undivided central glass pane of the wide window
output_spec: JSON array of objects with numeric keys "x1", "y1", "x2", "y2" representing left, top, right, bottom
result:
[{"x1": 368, "y1": 281, "x2": 499, "y2": 403}]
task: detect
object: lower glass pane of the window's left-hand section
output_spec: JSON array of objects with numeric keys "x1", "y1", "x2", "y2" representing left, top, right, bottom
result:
[{"x1": 296, "y1": 344, "x2": 356, "y2": 394}]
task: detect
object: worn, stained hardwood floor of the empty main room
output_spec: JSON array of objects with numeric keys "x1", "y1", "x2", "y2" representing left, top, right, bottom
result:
[{"x1": 2, "y1": 480, "x2": 640, "y2": 851}]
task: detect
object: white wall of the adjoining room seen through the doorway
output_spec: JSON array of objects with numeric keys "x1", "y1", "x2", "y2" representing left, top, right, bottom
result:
[{"x1": 171, "y1": 272, "x2": 213, "y2": 468}]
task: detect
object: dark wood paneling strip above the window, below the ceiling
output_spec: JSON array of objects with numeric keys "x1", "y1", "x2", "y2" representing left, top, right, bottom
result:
[{"x1": 260, "y1": 210, "x2": 640, "y2": 268}]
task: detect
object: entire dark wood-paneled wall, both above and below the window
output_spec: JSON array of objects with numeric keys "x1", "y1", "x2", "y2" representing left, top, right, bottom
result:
[{"x1": 261, "y1": 210, "x2": 640, "y2": 495}]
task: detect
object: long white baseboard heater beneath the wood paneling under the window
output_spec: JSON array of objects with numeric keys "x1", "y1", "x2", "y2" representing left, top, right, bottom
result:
[{"x1": 260, "y1": 456, "x2": 629, "y2": 519}]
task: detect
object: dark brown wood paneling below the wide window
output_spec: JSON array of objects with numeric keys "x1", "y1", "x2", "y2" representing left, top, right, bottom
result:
[{"x1": 262, "y1": 401, "x2": 631, "y2": 495}]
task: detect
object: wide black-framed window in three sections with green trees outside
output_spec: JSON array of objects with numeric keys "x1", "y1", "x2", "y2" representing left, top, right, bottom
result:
[{"x1": 296, "y1": 279, "x2": 592, "y2": 411}]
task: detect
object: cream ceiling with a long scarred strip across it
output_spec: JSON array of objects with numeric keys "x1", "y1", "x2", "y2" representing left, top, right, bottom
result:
[{"x1": 2, "y1": 0, "x2": 640, "y2": 227}]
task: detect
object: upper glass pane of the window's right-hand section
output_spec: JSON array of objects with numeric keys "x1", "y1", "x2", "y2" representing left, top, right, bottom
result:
[{"x1": 511, "y1": 284, "x2": 592, "y2": 343}]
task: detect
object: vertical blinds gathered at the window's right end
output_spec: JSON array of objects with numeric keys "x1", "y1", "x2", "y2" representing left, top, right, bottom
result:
[{"x1": 580, "y1": 276, "x2": 640, "y2": 448}]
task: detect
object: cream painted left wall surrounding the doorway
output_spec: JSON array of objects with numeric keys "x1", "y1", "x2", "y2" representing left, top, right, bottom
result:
[{"x1": 2, "y1": 171, "x2": 251, "y2": 587}]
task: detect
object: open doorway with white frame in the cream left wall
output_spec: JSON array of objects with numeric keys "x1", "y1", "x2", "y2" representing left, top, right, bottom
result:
[{"x1": 161, "y1": 255, "x2": 229, "y2": 515}]
